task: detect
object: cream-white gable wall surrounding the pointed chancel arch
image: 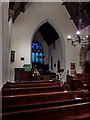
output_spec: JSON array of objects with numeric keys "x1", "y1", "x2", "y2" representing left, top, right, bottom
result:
[{"x1": 11, "y1": 2, "x2": 80, "y2": 80}]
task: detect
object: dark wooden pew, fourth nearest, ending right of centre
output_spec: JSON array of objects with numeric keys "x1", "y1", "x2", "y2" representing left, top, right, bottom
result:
[{"x1": 2, "y1": 85, "x2": 70, "y2": 96}]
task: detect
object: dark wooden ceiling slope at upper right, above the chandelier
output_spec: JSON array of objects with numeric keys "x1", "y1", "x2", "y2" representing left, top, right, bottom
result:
[{"x1": 63, "y1": 1, "x2": 90, "y2": 30}]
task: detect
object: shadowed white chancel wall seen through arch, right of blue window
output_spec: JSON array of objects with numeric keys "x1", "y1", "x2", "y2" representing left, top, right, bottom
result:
[{"x1": 49, "y1": 38, "x2": 66, "y2": 82}]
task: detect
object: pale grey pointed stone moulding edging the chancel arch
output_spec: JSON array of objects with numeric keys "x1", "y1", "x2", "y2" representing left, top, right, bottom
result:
[{"x1": 31, "y1": 19, "x2": 66, "y2": 81}]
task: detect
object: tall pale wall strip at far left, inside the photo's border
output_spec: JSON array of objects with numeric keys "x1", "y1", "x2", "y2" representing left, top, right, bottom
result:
[{"x1": 2, "y1": 2, "x2": 9, "y2": 84}]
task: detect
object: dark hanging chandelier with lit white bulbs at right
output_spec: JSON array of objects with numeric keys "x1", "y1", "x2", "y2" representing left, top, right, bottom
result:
[{"x1": 67, "y1": 3, "x2": 89, "y2": 46}]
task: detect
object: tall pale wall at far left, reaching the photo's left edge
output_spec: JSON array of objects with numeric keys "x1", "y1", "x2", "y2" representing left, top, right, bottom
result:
[{"x1": 0, "y1": 2, "x2": 9, "y2": 86}]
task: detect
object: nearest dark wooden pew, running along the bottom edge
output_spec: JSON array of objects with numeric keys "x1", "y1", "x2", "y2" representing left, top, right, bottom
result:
[{"x1": 2, "y1": 102, "x2": 90, "y2": 120}]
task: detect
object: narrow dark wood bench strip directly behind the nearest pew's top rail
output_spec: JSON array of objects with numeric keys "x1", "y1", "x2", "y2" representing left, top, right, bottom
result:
[{"x1": 2, "y1": 95, "x2": 89, "y2": 112}]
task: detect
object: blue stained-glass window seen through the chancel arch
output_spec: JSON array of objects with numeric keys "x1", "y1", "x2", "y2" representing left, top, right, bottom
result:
[{"x1": 32, "y1": 40, "x2": 44, "y2": 64}]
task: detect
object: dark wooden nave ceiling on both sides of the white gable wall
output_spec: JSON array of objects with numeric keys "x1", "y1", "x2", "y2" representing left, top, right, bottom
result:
[{"x1": 9, "y1": 1, "x2": 90, "y2": 30}]
